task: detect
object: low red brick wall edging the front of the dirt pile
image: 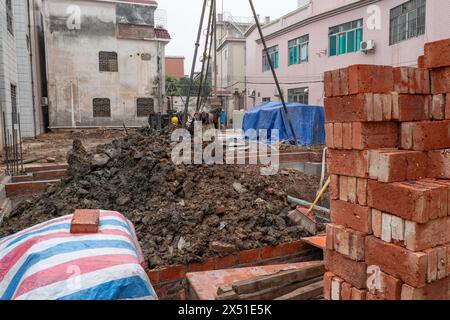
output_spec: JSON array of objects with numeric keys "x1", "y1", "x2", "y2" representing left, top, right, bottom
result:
[{"x1": 148, "y1": 241, "x2": 322, "y2": 300}]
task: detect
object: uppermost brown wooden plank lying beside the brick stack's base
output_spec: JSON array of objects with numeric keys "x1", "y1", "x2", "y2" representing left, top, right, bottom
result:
[{"x1": 232, "y1": 261, "x2": 325, "y2": 295}]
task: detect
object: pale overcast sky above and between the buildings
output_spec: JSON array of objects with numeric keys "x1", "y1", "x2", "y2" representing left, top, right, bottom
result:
[{"x1": 158, "y1": 0, "x2": 297, "y2": 74}]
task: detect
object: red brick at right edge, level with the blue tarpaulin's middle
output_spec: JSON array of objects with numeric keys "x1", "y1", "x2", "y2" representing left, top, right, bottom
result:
[{"x1": 401, "y1": 120, "x2": 450, "y2": 151}]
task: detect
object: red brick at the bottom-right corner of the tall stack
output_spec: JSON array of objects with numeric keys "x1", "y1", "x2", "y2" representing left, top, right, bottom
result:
[{"x1": 402, "y1": 277, "x2": 450, "y2": 301}]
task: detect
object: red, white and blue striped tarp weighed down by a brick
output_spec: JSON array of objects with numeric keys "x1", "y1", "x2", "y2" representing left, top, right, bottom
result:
[{"x1": 0, "y1": 211, "x2": 157, "y2": 300}]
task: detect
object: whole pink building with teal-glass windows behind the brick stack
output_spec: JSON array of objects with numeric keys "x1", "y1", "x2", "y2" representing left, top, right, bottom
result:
[{"x1": 246, "y1": 0, "x2": 450, "y2": 106}]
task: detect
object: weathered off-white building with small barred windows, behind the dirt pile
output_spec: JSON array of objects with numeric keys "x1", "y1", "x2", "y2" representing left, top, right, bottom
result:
[{"x1": 45, "y1": 0, "x2": 170, "y2": 129}]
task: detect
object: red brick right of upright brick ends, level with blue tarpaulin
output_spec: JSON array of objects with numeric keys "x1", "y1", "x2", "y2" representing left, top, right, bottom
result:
[{"x1": 352, "y1": 122, "x2": 399, "y2": 150}]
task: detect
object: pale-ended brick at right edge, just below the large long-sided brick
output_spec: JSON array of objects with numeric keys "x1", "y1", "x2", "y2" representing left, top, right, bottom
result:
[{"x1": 405, "y1": 216, "x2": 450, "y2": 251}]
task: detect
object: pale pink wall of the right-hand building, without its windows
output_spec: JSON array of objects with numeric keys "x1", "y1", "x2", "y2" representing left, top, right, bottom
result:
[{"x1": 246, "y1": 0, "x2": 450, "y2": 107}]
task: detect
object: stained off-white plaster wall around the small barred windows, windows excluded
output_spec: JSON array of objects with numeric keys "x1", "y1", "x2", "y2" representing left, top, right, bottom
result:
[{"x1": 46, "y1": 0, "x2": 164, "y2": 127}]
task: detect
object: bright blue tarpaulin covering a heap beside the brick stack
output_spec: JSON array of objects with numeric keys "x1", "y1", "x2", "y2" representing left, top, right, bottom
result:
[{"x1": 243, "y1": 102, "x2": 325, "y2": 145}]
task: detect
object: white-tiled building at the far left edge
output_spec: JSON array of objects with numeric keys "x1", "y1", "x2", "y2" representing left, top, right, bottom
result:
[{"x1": 0, "y1": 0, "x2": 45, "y2": 151}]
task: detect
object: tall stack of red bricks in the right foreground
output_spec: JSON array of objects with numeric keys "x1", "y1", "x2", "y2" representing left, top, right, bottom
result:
[{"x1": 324, "y1": 39, "x2": 450, "y2": 300}]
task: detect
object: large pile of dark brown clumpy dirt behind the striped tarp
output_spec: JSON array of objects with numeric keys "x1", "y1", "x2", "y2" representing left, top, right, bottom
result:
[{"x1": 0, "y1": 129, "x2": 327, "y2": 268}]
